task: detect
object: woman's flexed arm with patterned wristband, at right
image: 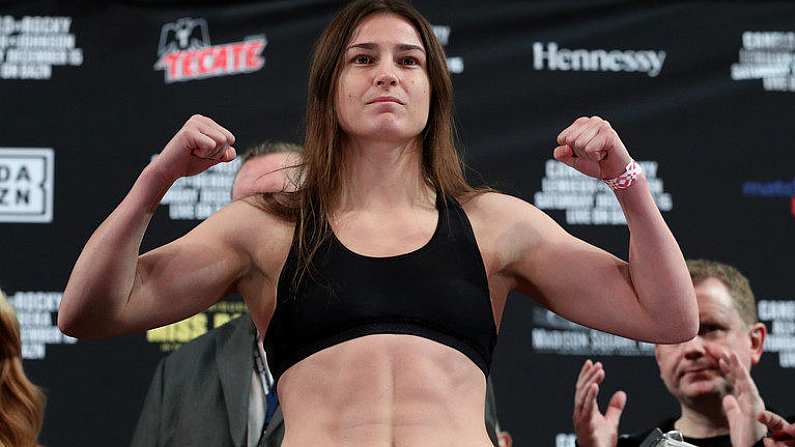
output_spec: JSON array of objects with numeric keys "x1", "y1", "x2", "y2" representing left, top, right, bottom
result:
[{"x1": 501, "y1": 117, "x2": 698, "y2": 343}]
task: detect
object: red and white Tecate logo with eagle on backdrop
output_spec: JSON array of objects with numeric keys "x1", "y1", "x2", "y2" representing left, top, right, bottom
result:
[{"x1": 155, "y1": 18, "x2": 268, "y2": 83}]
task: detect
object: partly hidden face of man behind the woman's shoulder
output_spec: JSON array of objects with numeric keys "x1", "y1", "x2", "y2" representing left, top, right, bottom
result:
[{"x1": 232, "y1": 152, "x2": 300, "y2": 200}]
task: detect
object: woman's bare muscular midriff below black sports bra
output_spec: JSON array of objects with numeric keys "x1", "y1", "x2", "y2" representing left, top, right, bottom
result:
[{"x1": 278, "y1": 334, "x2": 491, "y2": 447}]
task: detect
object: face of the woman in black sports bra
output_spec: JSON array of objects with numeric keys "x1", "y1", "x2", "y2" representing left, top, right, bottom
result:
[{"x1": 335, "y1": 13, "x2": 430, "y2": 142}]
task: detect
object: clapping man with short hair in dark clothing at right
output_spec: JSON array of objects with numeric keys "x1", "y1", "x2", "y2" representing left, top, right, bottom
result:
[{"x1": 573, "y1": 260, "x2": 787, "y2": 447}]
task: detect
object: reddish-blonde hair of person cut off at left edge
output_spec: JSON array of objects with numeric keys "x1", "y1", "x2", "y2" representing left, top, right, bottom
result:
[{"x1": 0, "y1": 290, "x2": 44, "y2": 447}]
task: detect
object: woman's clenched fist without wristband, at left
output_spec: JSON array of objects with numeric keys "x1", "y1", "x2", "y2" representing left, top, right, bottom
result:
[{"x1": 153, "y1": 115, "x2": 236, "y2": 181}]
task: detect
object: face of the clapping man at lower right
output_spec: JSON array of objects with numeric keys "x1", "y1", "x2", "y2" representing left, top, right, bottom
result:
[{"x1": 655, "y1": 278, "x2": 765, "y2": 402}]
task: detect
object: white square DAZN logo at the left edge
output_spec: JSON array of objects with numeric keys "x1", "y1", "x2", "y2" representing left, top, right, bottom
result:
[{"x1": 0, "y1": 148, "x2": 55, "y2": 223}]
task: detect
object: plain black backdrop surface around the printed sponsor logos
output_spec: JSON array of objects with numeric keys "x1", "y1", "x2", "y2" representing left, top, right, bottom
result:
[{"x1": 0, "y1": 0, "x2": 795, "y2": 447}]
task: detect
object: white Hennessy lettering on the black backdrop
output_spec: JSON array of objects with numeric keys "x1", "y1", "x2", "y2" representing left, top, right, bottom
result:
[{"x1": 533, "y1": 42, "x2": 665, "y2": 78}]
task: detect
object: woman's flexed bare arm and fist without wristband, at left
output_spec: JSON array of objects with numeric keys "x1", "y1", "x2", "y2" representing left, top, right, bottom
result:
[{"x1": 58, "y1": 115, "x2": 250, "y2": 338}]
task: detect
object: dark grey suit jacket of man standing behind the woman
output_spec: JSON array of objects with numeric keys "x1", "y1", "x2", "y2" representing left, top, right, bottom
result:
[{"x1": 131, "y1": 314, "x2": 284, "y2": 447}]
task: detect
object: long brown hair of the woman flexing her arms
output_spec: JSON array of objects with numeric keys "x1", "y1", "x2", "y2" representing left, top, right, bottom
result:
[{"x1": 268, "y1": 0, "x2": 486, "y2": 283}]
